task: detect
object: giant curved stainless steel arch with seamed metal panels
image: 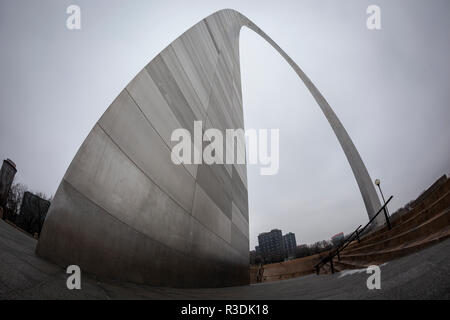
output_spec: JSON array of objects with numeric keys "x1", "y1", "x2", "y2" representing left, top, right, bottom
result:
[{"x1": 37, "y1": 9, "x2": 380, "y2": 287}]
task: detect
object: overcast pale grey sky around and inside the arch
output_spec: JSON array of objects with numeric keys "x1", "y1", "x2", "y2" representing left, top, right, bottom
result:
[{"x1": 0, "y1": 0, "x2": 450, "y2": 248}]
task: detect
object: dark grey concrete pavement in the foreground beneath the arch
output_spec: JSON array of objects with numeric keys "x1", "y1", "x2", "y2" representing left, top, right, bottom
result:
[{"x1": 0, "y1": 221, "x2": 450, "y2": 300}]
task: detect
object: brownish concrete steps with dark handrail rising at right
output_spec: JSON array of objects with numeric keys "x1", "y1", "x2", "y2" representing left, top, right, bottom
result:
[{"x1": 328, "y1": 176, "x2": 450, "y2": 273}]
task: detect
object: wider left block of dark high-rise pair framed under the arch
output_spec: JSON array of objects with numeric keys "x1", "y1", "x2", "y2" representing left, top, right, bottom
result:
[{"x1": 258, "y1": 229, "x2": 285, "y2": 263}]
